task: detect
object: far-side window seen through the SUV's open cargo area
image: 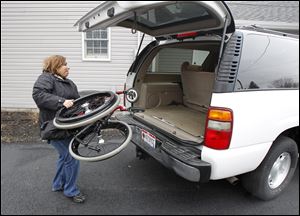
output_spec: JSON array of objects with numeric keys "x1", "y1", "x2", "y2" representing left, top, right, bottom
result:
[{"x1": 147, "y1": 48, "x2": 210, "y2": 74}]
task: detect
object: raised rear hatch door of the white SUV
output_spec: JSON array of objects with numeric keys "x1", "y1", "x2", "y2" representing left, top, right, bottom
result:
[{"x1": 75, "y1": 1, "x2": 235, "y2": 38}]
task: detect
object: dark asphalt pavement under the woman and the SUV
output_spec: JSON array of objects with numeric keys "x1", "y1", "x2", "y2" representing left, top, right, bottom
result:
[{"x1": 1, "y1": 143, "x2": 299, "y2": 215}]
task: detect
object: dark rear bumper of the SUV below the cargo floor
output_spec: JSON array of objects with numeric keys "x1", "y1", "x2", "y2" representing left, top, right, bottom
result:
[{"x1": 118, "y1": 114, "x2": 211, "y2": 182}]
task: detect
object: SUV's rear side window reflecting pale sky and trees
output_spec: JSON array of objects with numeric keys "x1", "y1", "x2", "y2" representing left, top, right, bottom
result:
[{"x1": 235, "y1": 34, "x2": 299, "y2": 91}]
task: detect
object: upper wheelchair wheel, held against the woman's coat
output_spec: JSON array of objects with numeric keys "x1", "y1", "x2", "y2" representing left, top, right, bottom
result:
[{"x1": 53, "y1": 91, "x2": 120, "y2": 129}]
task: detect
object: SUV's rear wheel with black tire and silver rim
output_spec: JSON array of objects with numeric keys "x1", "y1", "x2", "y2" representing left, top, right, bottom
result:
[{"x1": 241, "y1": 136, "x2": 298, "y2": 200}]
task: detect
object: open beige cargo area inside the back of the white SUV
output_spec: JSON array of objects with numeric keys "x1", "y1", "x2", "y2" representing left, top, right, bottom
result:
[{"x1": 134, "y1": 43, "x2": 218, "y2": 143}]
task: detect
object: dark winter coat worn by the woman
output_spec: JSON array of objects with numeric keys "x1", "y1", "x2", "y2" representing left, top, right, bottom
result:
[{"x1": 32, "y1": 72, "x2": 80, "y2": 125}]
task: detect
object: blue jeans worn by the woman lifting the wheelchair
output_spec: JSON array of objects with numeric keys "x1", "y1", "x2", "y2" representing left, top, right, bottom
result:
[{"x1": 50, "y1": 139, "x2": 80, "y2": 197}]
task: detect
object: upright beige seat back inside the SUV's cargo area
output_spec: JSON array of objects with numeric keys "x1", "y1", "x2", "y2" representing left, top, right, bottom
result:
[{"x1": 181, "y1": 62, "x2": 215, "y2": 111}]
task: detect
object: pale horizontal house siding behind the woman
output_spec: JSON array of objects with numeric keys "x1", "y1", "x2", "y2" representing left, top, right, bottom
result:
[{"x1": 1, "y1": 1, "x2": 151, "y2": 108}]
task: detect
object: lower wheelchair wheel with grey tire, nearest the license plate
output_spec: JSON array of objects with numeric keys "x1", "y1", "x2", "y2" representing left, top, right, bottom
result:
[{"x1": 69, "y1": 120, "x2": 132, "y2": 162}]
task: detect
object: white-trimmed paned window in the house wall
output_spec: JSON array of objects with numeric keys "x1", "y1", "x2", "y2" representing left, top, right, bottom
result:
[{"x1": 83, "y1": 28, "x2": 110, "y2": 61}]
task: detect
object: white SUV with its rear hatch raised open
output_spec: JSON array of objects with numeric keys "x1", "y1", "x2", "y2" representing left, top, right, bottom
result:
[{"x1": 77, "y1": 1, "x2": 299, "y2": 200}]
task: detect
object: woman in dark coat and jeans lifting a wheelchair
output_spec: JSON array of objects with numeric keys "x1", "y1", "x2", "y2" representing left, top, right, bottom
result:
[{"x1": 32, "y1": 55, "x2": 85, "y2": 203}]
